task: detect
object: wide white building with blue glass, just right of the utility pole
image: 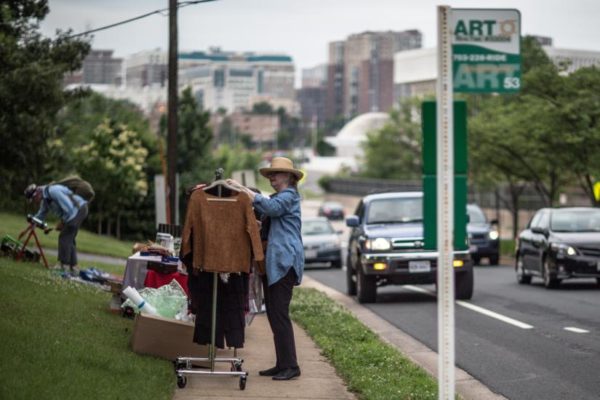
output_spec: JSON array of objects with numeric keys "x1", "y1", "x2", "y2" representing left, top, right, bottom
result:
[{"x1": 179, "y1": 48, "x2": 295, "y2": 112}]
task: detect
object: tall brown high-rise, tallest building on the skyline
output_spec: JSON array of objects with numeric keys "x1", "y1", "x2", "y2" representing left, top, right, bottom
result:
[{"x1": 327, "y1": 30, "x2": 422, "y2": 118}]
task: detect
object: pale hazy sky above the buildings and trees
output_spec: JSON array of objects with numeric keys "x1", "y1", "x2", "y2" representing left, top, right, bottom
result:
[{"x1": 42, "y1": 0, "x2": 600, "y2": 85}]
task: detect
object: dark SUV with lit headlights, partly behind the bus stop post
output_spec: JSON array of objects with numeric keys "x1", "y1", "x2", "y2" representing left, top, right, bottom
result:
[{"x1": 346, "y1": 192, "x2": 473, "y2": 303}]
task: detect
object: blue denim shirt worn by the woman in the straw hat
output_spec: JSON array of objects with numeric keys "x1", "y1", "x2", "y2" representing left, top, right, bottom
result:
[{"x1": 253, "y1": 188, "x2": 304, "y2": 286}]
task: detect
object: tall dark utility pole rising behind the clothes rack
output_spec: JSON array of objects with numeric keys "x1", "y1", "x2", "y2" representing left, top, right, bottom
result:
[{"x1": 167, "y1": 0, "x2": 178, "y2": 224}]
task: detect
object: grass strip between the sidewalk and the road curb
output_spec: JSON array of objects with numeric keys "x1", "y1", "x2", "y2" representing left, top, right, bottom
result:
[{"x1": 290, "y1": 288, "x2": 438, "y2": 400}]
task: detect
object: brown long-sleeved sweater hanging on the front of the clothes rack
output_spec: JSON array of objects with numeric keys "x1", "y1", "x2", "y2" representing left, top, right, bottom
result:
[{"x1": 180, "y1": 189, "x2": 264, "y2": 273}]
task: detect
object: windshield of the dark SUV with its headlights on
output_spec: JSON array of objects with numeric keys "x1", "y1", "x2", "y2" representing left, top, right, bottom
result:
[{"x1": 367, "y1": 197, "x2": 423, "y2": 224}]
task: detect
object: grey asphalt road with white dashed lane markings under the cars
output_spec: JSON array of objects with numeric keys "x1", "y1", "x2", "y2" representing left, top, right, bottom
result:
[{"x1": 303, "y1": 198, "x2": 600, "y2": 400}]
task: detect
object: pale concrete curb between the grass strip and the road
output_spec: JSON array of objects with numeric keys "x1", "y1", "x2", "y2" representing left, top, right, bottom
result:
[{"x1": 301, "y1": 275, "x2": 506, "y2": 400}]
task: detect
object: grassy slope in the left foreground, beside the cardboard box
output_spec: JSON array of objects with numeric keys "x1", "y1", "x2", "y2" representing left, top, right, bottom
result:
[{"x1": 0, "y1": 257, "x2": 175, "y2": 400}]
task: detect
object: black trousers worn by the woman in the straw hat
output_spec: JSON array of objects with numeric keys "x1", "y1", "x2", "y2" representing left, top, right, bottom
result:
[{"x1": 263, "y1": 268, "x2": 298, "y2": 369}]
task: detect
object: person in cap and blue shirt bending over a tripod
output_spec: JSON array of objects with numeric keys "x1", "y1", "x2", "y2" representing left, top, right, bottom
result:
[{"x1": 25, "y1": 183, "x2": 88, "y2": 273}]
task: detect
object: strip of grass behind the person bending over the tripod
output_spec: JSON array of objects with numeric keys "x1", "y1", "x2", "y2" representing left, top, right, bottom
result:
[{"x1": 0, "y1": 212, "x2": 133, "y2": 258}]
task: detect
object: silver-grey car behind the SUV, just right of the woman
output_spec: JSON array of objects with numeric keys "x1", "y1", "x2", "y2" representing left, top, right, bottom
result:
[{"x1": 302, "y1": 217, "x2": 342, "y2": 268}]
